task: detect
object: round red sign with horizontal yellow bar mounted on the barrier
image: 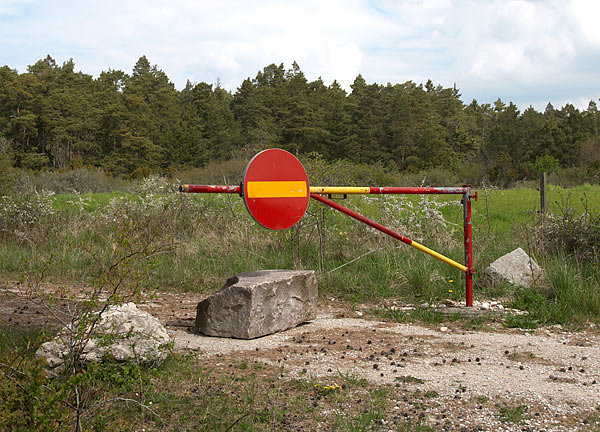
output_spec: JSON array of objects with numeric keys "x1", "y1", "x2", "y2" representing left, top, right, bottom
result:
[{"x1": 243, "y1": 149, "x2": 310, "y2": 230}]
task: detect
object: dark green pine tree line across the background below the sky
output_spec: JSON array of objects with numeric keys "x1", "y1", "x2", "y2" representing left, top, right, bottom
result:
[{"x1": 0, "y1": 56, "x2": 600, "y2": 184}]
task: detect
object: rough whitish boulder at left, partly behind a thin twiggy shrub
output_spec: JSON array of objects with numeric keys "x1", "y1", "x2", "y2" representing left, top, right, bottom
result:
[{"x1": 36, "y1": 303, "x2": 171, "y2": 372}]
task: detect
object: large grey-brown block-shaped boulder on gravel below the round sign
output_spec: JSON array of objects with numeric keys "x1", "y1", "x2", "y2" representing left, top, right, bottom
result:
[{"x1": 194, "y1": 270, "x2": 317, "y2": 339}]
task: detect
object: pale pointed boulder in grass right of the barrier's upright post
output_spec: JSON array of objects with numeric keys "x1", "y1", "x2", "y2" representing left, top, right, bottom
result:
[{"x1": 478, "y1": 248, "x2": 543, "y2": 288}]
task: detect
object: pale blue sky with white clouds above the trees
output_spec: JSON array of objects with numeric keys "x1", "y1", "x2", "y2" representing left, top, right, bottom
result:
[{"x1": 0, "y1": 0, "x2": 600, "y2": 111}]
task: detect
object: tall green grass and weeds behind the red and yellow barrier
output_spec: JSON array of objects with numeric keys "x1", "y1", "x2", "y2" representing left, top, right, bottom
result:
[{"x1": 0, "y1": 185, "x2": 600, "y2": 325}]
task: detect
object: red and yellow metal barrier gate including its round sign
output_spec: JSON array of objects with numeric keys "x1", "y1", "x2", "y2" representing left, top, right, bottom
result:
[{"x1": 179, "y1": 149, "x2": 477, "y2": 306}]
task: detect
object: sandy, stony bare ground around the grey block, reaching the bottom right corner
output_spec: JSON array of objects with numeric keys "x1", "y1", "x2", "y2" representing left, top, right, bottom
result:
[{"x1": 0, "y1": 285, "x2": 600, "y2": 431}]
